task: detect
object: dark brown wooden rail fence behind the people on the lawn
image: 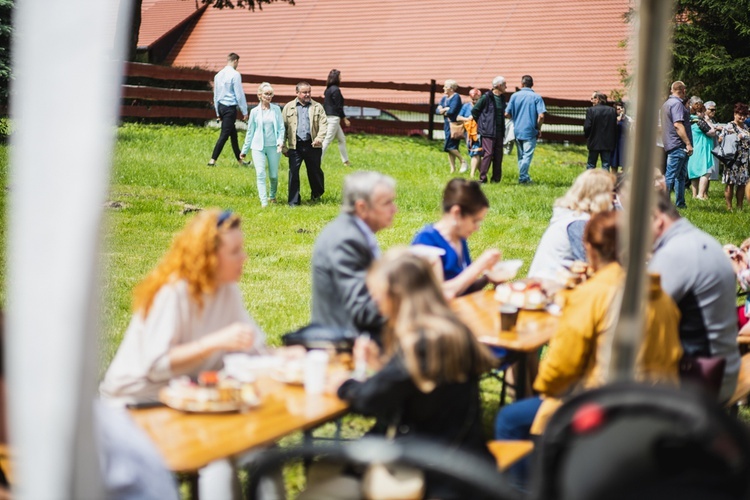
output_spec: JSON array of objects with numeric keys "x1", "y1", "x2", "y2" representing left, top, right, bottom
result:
[{"x1": 120, "y1": 63, "x2": 590, "y2": 144}]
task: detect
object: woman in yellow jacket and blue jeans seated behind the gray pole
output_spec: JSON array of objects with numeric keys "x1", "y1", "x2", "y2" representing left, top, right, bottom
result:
[{"x1": 495, "y1": 212, "x2": 682, "y2": 439}]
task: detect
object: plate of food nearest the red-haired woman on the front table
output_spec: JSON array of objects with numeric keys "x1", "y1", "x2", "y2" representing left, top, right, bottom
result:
[{"x1": 159, "y1": 372, "x2": 260, "y2": 413}]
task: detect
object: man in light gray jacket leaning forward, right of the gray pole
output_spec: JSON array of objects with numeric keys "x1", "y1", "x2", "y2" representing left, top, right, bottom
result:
[{"x1": 649, "y1": 193, "x2": 740, "y2": 402}]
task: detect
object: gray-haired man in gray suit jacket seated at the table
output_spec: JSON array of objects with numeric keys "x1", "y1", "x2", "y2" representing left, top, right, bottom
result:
[{"x1": 312, "y1": 172, "x2": 396, "y2": 337}]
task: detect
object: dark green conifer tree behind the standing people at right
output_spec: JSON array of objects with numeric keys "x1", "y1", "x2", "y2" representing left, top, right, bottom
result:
[{"x1": 672, "y1": 0, "x2": 750, "y2": 120}]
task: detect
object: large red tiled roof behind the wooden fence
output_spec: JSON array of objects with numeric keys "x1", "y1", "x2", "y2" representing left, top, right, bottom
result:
[{"x1": 145, "y1": 0, "x2": 631, "y2": 99}]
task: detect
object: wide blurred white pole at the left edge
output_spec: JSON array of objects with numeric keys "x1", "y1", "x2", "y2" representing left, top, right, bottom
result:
[{"x1": 6, "y1": 0, "x2": 130, "y2": 499}]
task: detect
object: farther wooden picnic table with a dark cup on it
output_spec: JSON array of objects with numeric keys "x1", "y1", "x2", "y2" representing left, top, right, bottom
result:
[{"x1": 450, "y1": 290, "x2": 559, "y2": 395}]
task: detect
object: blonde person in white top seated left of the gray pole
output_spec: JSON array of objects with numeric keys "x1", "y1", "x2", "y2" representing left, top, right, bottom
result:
[{"x1": 529, "y1": 169, "x2": 615, "y2": 278}]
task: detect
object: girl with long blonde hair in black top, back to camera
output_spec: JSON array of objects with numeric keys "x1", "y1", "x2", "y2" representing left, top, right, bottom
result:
[{"x1": 338, "y1": 249, "x2": 495, "y2": 498}]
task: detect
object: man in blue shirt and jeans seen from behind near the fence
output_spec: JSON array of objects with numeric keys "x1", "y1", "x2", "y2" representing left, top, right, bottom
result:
[{"x1": 505, "y1": 75, "x2": 547, "y2": 184}]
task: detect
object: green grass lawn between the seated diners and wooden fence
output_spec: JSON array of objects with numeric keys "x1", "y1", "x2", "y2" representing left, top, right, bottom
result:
[{"x1": 0, "y1": 124, "x2": 750, "y2": 496}]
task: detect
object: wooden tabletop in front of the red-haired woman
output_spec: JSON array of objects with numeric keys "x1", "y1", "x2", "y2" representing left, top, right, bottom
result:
[{"x1": 130, "y1": 377, "x2": 348, "y2": 472}]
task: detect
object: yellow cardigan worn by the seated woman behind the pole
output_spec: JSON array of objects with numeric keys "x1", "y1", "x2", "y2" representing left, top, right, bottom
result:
[{"x1": 531, "y1": 263, "x2": 682, "y2": 434}]
